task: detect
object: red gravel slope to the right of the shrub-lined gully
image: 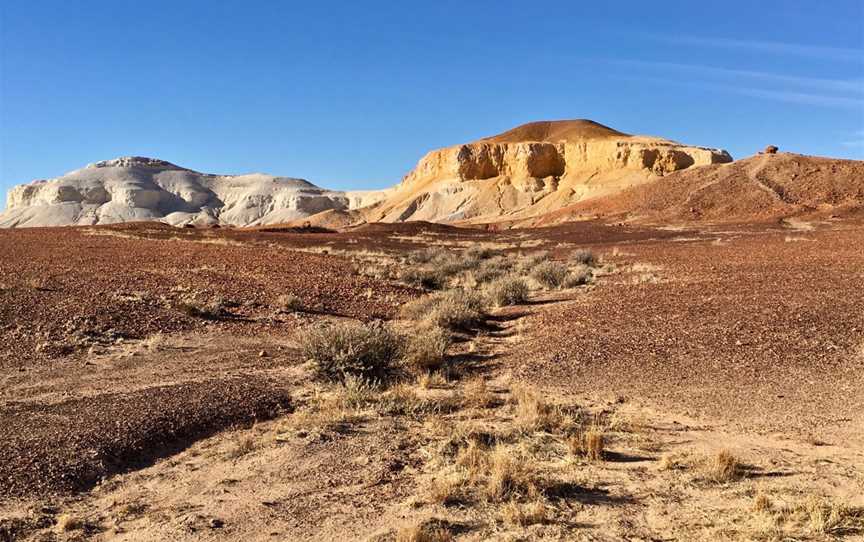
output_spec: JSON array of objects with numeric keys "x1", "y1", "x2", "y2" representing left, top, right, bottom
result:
[{"x1": 502, "y1": 223, "x2": 864, "y2": 438}]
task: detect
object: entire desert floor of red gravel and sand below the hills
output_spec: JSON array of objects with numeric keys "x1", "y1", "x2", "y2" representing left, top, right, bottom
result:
[{"x1": 0, "y1": 219, "x2": 864, "y2": 542}]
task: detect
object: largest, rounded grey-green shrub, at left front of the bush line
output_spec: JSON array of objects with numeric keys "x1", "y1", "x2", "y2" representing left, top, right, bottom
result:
[{"x1": 300, "y1": 322, "x2": 403, "y2": 381}]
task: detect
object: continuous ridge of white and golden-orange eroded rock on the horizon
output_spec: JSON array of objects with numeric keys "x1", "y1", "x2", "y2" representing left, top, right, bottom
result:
[{"x1": 0, "y1": 120, "x2": 732, "y2": 227}]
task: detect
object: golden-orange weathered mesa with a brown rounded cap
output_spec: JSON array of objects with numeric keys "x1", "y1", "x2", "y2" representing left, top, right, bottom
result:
[{"x1": 369, "y1": 121, "x2": 732, "y2": 222}]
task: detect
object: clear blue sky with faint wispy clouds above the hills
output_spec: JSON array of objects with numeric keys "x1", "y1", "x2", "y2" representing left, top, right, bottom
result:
[{"x1": 0, "y1": 0, "x2": 864, "y2": 198}]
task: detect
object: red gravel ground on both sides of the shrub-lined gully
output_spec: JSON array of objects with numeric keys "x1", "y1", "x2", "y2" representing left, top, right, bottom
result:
[{"x1": 0, "y1": 218, "x2": 864, "y2": 506}]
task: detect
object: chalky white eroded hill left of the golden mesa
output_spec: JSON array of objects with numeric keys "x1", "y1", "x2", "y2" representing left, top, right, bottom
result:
[{"x1": 0, "y1": 157, "x2": 383, "y2": 227}]
